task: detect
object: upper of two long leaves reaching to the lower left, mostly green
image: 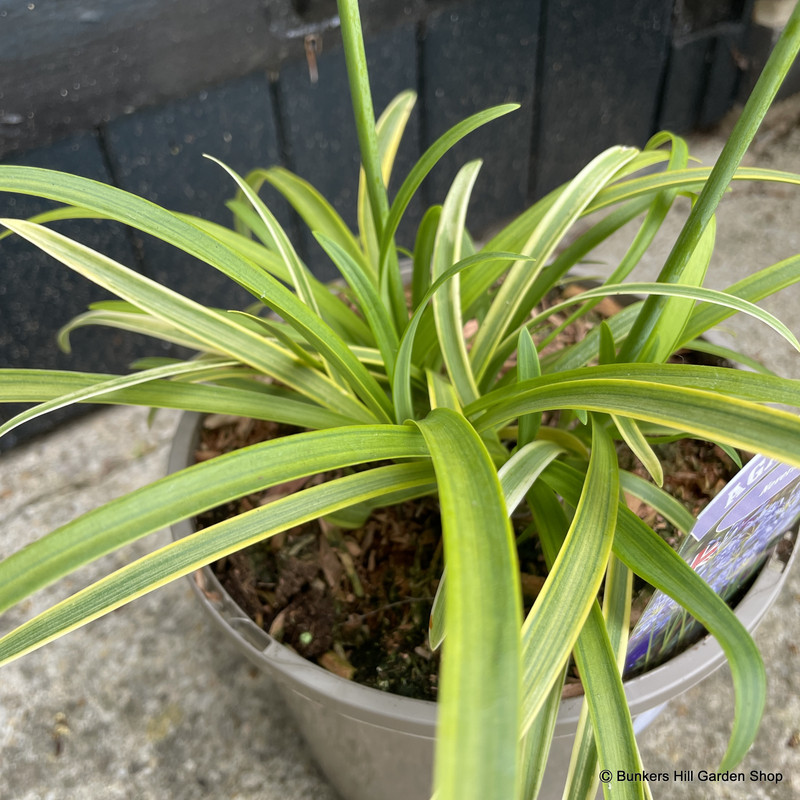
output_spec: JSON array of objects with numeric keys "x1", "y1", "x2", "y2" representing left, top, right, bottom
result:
[{"x1": 0, "y1": 426, "x2": 427, "y2": 610}]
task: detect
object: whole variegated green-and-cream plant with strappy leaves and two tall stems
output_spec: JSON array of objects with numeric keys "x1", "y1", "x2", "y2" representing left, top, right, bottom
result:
[{"x1": 0, "y1": 0, "x2": 800, "y2": 800}]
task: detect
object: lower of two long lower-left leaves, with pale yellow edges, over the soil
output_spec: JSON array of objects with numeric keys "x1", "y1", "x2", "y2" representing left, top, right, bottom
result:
[{"x1": 0, "y1": 462, "x2": 431, "y2": 665}]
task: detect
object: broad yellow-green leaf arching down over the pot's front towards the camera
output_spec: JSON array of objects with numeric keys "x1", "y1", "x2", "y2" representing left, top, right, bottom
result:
[{"x1": 417, "y1": 409, "x2": 521, "y2": 800}]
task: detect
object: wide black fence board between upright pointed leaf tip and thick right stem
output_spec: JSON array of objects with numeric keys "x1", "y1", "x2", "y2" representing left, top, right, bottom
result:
[{"x1": 533, "y1": 0, "x2": 672, "y2": 197}]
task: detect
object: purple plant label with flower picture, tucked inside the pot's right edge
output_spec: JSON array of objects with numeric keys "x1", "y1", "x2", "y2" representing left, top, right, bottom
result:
[{"x1": 625, "y1": 455, "x2": 800, "y2": 676}]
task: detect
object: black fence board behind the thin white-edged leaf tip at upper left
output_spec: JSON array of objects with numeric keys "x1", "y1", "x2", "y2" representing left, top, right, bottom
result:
[{"x1": 106, "y1": 74, "x2": 289, "y2": 308}]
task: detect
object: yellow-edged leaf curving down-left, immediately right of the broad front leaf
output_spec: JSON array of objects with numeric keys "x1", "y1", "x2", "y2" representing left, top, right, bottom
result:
[{"x1": 520, "y1": 423, "x2": 619, "y2": 732}]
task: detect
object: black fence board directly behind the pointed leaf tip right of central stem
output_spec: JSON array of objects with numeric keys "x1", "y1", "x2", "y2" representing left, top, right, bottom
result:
[{"x1": 422, "y1": 0, "x2": 540, "y2": 234}]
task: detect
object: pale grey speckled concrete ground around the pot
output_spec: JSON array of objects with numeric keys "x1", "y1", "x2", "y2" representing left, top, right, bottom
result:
[{"x1": 0, "y1": 100, "x2": 800, "y2": 800}]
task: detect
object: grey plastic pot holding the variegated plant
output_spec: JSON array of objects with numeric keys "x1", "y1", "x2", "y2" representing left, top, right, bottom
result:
[{"x1": 169, "y1": 413, "x2": 797, "y2": 800}]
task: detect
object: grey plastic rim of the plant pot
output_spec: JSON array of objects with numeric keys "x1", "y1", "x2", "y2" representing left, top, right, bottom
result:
[{"x1": 168, "y1": 411, "x2": 798, "y2": 737}]
